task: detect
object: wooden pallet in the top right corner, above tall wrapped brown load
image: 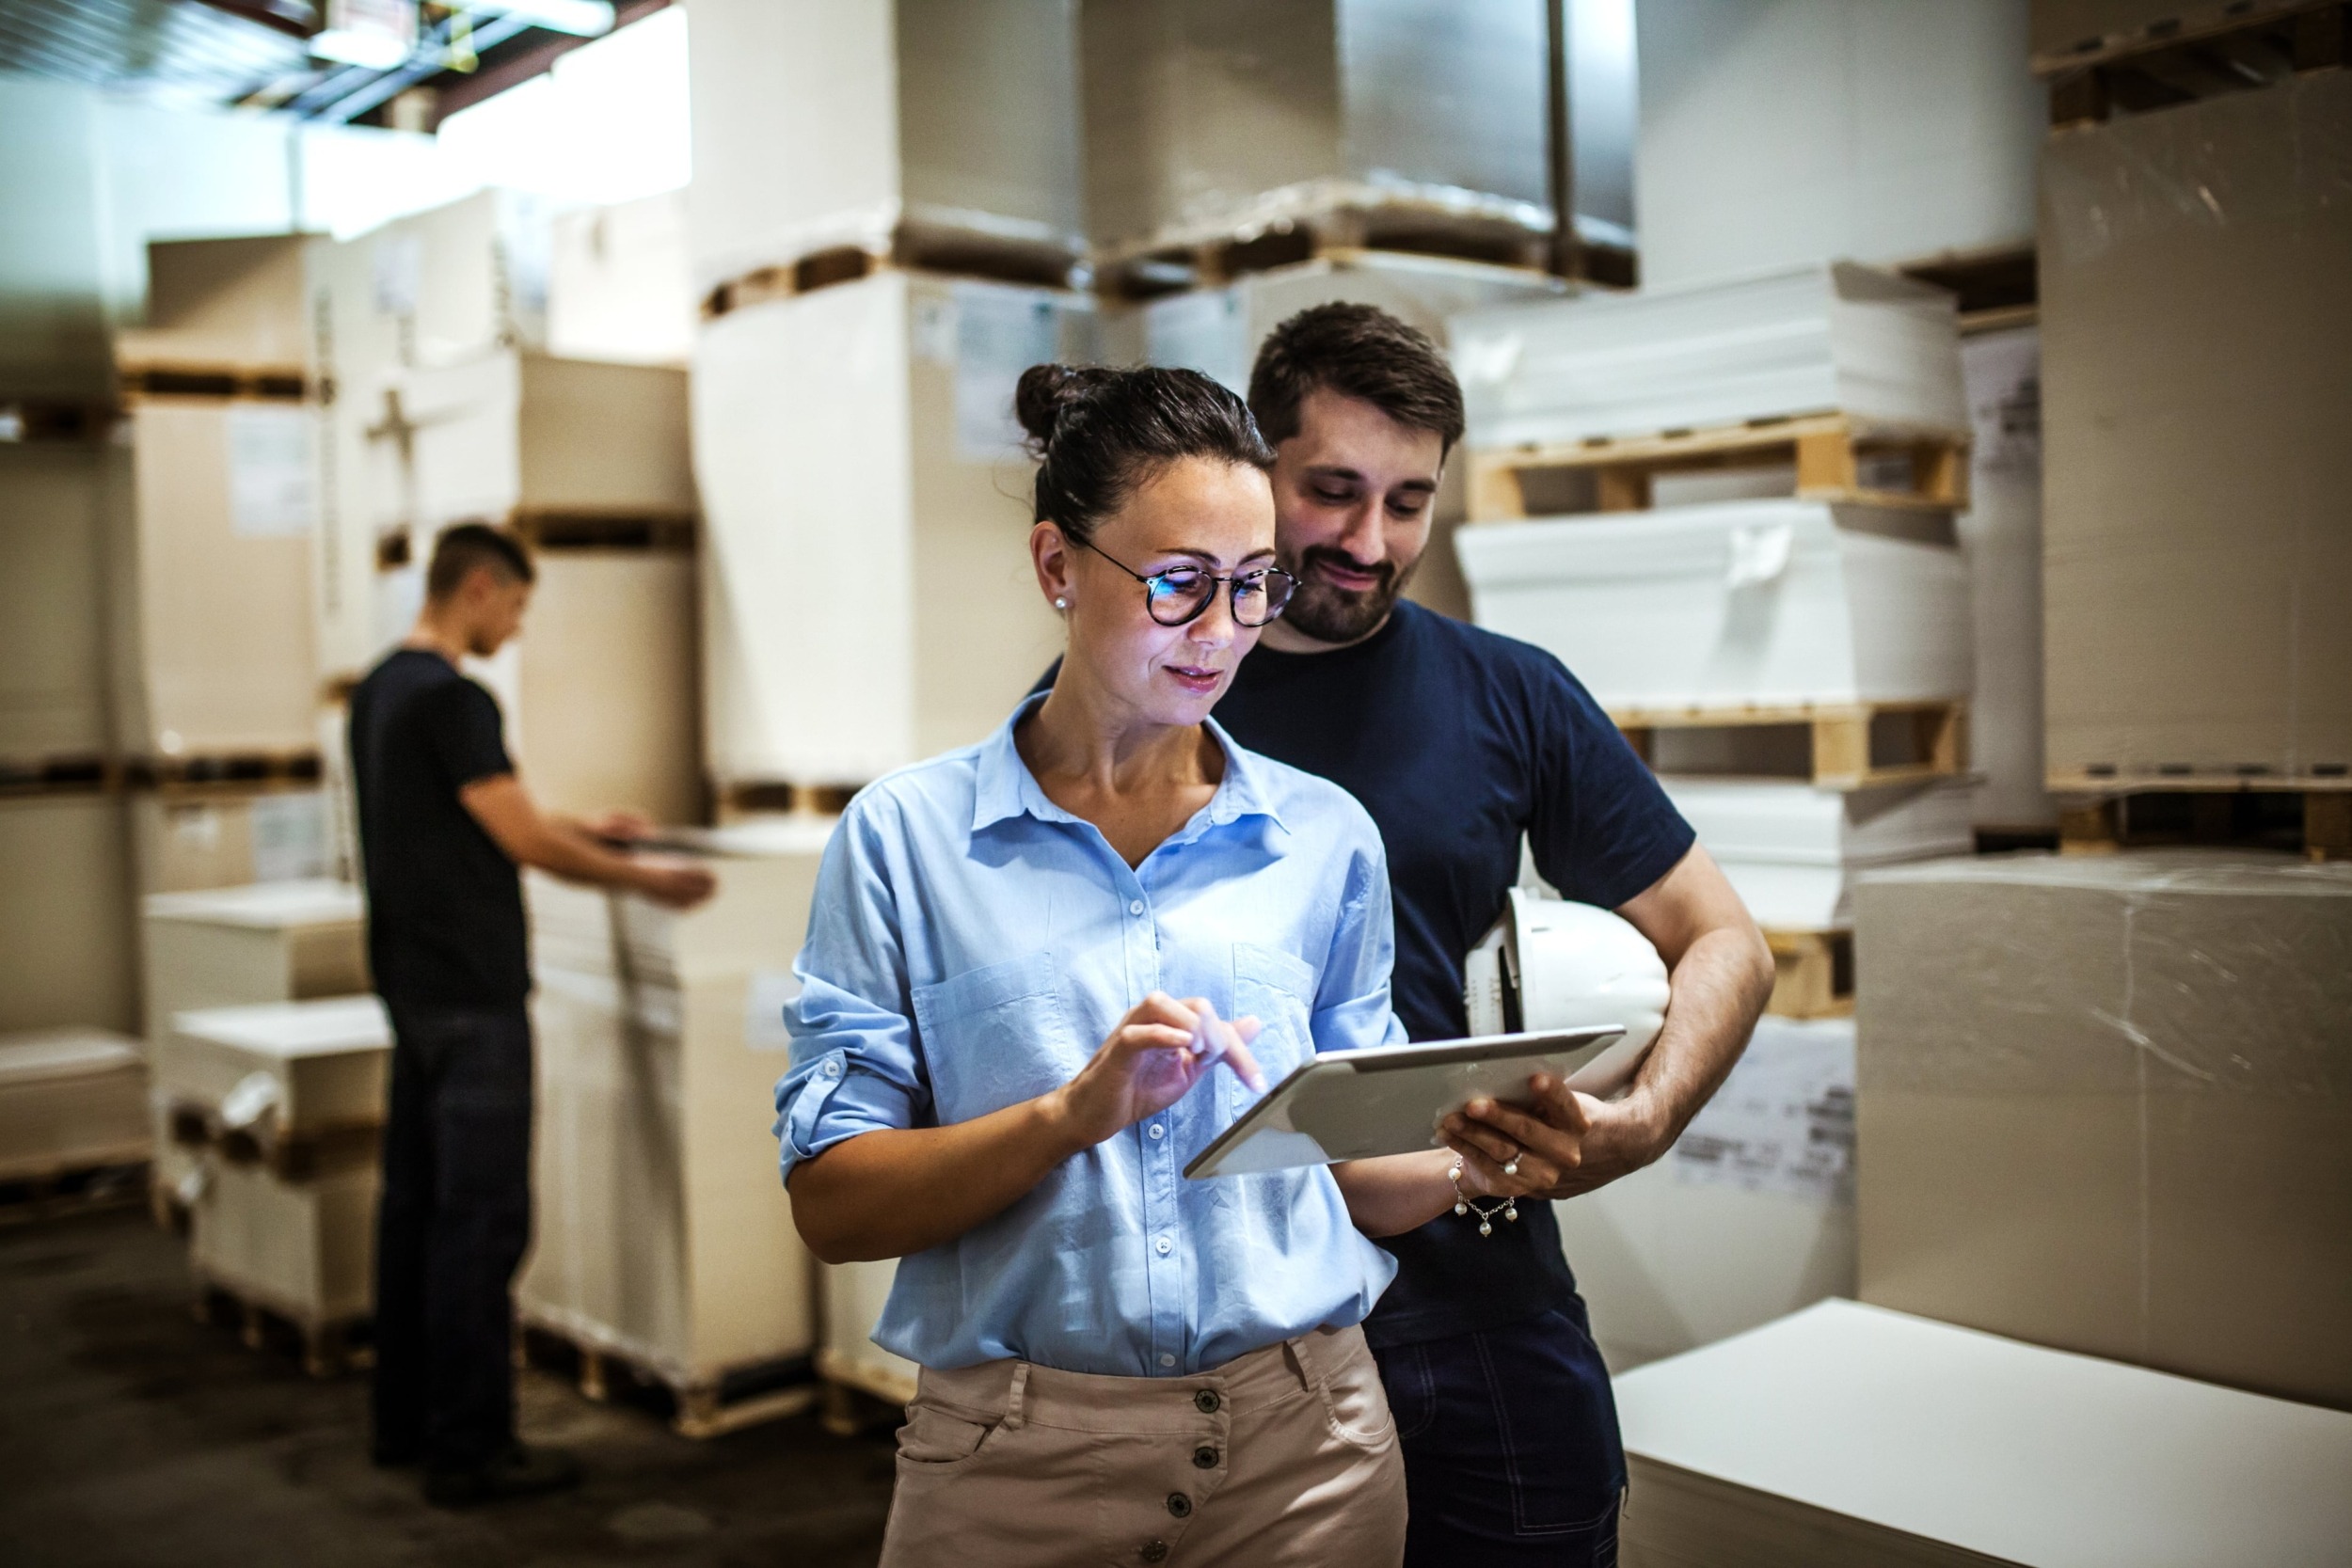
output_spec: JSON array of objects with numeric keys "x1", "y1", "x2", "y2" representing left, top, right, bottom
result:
[{"x1": 2032, "y1": 0, "x2": 2352, "y2": 127}]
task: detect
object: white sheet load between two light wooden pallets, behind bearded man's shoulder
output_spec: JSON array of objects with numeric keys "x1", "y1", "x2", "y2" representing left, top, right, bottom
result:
[{"x1": 1454, "y1": 500, "x2": 1974, "y2": 710}]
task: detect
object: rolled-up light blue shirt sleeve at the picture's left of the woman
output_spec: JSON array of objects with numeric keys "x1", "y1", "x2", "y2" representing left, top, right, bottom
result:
[{"x1": 774, "y1": 800, "x2": 931, "y2": 1180}]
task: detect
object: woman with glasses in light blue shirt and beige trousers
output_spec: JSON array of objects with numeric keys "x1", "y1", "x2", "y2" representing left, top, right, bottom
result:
[{"x1": 776, "y1": 364, "x2": 1532, "y2": 1568}]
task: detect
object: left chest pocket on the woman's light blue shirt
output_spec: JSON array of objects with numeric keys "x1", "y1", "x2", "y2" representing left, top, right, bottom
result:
[{"x1": 915, "y1": 952, "x2": 1087, "y2": 1124}]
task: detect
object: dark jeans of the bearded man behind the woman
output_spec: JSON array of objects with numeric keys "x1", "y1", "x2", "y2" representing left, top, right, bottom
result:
[{"x1": 1376, "y1": 1300, "x2": 1626, "y2": 1568}]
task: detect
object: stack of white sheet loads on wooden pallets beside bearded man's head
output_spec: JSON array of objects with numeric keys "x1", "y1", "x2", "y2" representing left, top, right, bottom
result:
[{"x1": 1452, "y1": 263, "x2": 1974, "y2": 1016}]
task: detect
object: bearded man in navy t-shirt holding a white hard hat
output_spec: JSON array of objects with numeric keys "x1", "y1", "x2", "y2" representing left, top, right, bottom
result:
[{"x1": 1216, "y1": 303, "x2": 1773, "y2": 1568}]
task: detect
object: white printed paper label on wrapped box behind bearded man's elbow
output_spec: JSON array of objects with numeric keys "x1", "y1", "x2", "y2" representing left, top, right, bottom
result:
[{"x1": 1675, "y1": 1021, "x2": 1853, "y2": 1204}]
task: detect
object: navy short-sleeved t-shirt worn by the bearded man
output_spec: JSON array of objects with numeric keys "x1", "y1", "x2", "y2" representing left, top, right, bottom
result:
[{"x1": 1216, "y1": 602, "x2": 1693, "y2": 1345}]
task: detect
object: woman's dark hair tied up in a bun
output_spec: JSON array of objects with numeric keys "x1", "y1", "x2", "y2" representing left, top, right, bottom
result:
[{"x1": 1014, "y1": 364, "x2": 1275, "y2": 543}]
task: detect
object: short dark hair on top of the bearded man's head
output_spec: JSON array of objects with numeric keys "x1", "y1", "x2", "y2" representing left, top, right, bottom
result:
[{"x1": 1249, "y1": 303, "x2": 1463, "y2": 451}]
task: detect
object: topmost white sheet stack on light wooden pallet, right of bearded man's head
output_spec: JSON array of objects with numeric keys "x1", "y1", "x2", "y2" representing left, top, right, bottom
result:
[{"x1": 1449, "y1": 261, "x2": 1969, "y2": 449}]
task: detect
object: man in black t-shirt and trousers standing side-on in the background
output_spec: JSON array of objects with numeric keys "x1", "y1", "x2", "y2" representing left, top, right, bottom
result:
[{"x1": 351, "y1": 524, "x2": 713, "y2": 1507}]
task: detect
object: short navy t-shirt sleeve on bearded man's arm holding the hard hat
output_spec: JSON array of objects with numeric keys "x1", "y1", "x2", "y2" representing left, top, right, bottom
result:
[{"x1": 1527, "y1": 658, "x2": 1698, "y2": 910}]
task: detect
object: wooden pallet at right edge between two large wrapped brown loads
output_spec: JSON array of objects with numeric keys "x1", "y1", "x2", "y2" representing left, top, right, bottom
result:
[{"x1": 2049, "y1": 771, "x2": 2352, "y2": 861}]
